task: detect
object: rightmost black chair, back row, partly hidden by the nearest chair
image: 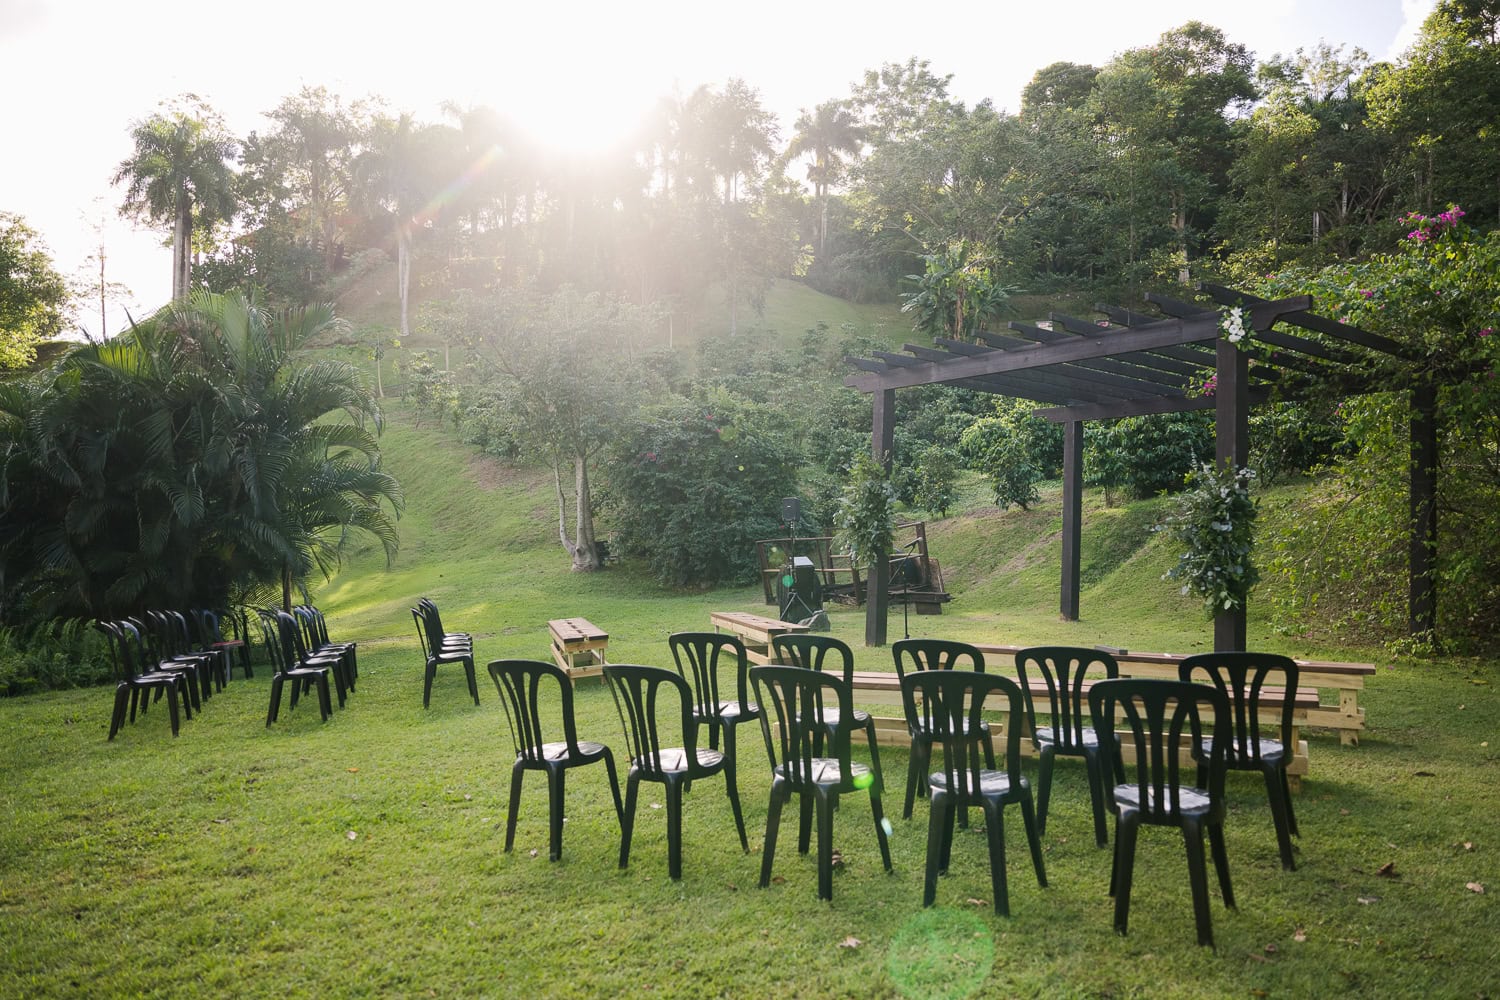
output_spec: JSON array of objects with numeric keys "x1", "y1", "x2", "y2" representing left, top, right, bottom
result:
[{"x1": 1178, "y1": 652, "x2": 1301, "y2": 871}]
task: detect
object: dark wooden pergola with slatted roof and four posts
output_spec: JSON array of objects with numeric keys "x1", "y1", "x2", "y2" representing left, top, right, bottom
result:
[{"x1": 845, "y1": 285, "x2": 1437, "y2": 651}]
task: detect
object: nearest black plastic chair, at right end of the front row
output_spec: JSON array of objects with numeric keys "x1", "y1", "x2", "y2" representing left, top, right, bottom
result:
[{"x1": 1089, "y1": 678, "x2": 1235, "y2": 945}]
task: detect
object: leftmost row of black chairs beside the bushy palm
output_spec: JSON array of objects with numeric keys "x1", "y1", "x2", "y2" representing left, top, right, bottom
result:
[{"x1": 95, "y1": 609, "x2": 251, "y2": 739}]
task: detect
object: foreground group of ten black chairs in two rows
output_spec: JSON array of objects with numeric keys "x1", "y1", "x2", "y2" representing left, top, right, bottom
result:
[{"x1": 489, "y1": 633, "x2": 1298, "y2": 943}]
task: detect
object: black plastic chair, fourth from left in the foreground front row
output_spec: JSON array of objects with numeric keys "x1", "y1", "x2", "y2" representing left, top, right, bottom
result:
[{"x1": 902, "y1": 670, "x2": 1047, "y2": 916}]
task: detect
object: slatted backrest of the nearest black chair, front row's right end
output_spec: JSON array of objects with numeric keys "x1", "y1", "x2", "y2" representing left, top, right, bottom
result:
[{"x1": 1089, "y1": 678, "x2": 1229, "y2": 825}]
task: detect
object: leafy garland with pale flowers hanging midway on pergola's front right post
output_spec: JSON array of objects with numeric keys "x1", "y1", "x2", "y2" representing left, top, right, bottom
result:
[{"x1": 1157, "y1": 465, "x2": 1260, "y2": 616}]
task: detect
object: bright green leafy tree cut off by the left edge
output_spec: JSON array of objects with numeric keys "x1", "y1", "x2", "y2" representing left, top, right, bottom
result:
[{"x1": 0, "y1": 211, "x2": 69, "y2": 369}]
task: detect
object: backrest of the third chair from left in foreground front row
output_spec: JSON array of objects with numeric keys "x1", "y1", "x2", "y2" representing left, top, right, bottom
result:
[{"x1": 750, "y1": 664, "x2": 854, "y2": 792}]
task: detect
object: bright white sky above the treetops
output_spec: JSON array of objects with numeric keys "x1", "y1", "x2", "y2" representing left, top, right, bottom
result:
[{"x1": 0, "y1": 0, "x2": 1434, "y2": 334}]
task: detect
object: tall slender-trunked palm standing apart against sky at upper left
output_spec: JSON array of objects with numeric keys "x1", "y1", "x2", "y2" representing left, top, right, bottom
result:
[{"x1": 113, "y1": 94, "x2": 237, "y2": 301}]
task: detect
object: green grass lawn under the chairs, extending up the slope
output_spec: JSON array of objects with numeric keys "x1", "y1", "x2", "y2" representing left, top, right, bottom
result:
[{"x1": 0, "y1": 412, "x2": 1500, "y2": 997}]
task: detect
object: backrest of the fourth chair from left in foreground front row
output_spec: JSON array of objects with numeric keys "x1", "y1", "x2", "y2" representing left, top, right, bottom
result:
[{"x1": 902, "y1": 670, "x2": 1023, "y2": 801}]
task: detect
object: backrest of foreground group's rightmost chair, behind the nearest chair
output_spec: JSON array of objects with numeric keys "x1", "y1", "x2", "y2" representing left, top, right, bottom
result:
[{"x1": 1178, "y1": 652, "x2": 1298, "y2": 768}]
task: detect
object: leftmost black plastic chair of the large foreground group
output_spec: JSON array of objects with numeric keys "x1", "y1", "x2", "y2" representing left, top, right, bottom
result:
[{"x1": 489, "y1": 660, "x2": 626, "y2": 861}]
